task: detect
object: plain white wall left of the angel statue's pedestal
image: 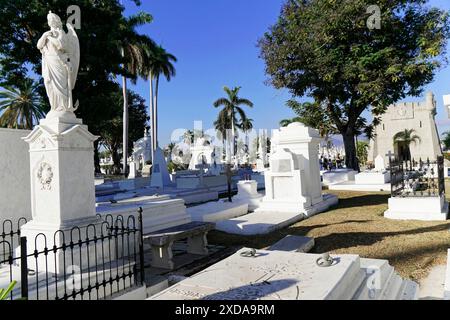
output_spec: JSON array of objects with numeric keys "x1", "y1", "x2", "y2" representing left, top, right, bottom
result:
[{"x1": 0, "y1": 128, "x2": 31, "y2": 221}]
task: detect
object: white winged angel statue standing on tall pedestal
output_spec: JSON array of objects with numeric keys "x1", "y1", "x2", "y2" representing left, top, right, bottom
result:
[{"x1": 37, "y1": 11, "x2": 80, "y2": 112}]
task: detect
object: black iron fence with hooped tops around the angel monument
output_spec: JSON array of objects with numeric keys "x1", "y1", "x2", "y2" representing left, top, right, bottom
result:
[{"x1": 0, "y1": 210, "x2": 145, "y2": 300}]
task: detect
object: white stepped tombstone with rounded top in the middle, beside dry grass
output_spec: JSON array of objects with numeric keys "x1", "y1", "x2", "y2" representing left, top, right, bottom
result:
[{"x1": 257, "y1": 123, "x2": 337, "y2": 214}]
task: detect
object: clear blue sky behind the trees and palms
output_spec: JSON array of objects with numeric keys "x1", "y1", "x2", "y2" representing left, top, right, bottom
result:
[{"x1": 124, "y1": 0, "x2": 450, "y2": 145}]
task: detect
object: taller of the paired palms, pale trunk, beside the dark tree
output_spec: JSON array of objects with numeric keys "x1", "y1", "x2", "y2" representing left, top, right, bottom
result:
[{"x1": 119, "y1": 12, "x2": 155, "y2": 175}]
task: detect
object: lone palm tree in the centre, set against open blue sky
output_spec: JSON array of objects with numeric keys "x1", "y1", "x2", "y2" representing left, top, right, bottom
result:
[{"x1": 213, "y1": 86, "x2": 253, "y2": 162}]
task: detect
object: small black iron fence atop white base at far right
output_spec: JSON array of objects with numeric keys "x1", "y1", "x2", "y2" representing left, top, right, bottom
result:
[{"x1": 389, "y1": 157, "x2": 445, "y2": 197}]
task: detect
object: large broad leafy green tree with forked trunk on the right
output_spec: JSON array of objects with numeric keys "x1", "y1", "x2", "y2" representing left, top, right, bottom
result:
[{"x1": 259, "y1": 0, "x2": 449, "y2": 170}]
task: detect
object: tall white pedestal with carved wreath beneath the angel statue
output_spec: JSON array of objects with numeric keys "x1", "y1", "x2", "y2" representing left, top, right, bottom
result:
[{"x1": 21, "y1": 116, "x2": 101, "y2": 273}]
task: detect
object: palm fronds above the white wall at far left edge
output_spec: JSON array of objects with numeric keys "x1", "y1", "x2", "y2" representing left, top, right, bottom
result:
[{"x1": 0, "y1": 79, "x2": 45, "y2": 130}]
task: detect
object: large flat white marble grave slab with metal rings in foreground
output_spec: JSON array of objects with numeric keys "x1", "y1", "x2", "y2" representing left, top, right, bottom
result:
[{"x1": 148, "y1": 248, "x2": 418, "y2": 301}]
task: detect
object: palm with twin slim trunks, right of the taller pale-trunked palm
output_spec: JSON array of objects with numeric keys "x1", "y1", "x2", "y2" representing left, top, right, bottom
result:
[{"x1": 147, "y1": 46, "x2": 177, "y2": 159}]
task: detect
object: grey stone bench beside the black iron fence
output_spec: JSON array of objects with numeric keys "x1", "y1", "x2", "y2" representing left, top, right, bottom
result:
[{"x1": 144, "y1": 222, "x2": 215, "y2": 270}]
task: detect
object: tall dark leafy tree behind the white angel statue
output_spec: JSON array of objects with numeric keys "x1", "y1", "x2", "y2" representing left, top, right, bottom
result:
[{"x1": 0, "y1": 0, "x2": 153, "y2": 172}]
